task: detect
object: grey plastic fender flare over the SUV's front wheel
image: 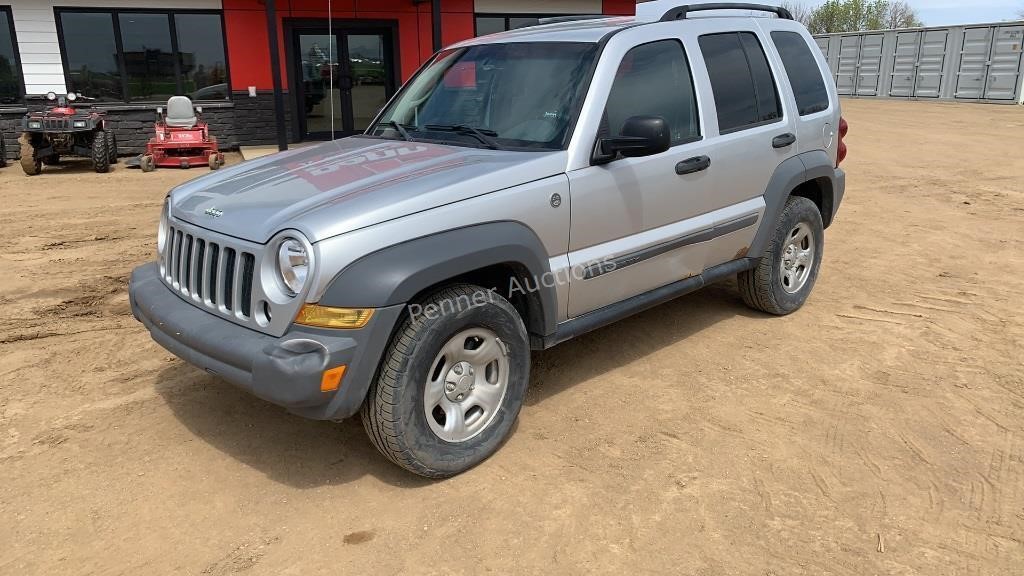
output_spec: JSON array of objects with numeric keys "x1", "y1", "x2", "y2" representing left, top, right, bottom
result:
[{"x1": 321, "y1": 221, "x2": 558, "y2": 336}]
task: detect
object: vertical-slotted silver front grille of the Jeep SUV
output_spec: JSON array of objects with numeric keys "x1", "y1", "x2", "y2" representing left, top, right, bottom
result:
[{"x1": 161, "y1": 224, "x2": 256, "y2": 321}]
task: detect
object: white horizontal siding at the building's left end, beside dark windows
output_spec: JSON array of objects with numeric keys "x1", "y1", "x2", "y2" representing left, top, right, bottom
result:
[{"x1": 5, "y1": 0, "x2": 221, "y2": 95}]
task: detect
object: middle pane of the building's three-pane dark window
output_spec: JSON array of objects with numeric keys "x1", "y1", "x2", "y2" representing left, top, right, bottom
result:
[{"x1": 118, "y1": 13, "x2": 177, "y2": 100}]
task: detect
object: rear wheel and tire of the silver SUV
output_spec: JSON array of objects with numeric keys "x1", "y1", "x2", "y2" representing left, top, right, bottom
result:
[{"x1": 736, "y1": 196, "x2": 824, "y2": 316}]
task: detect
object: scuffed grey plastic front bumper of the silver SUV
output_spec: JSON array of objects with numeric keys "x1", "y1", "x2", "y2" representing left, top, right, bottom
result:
[{"x1": 128, "y1": 263, "x2": 403, "y2": 420}]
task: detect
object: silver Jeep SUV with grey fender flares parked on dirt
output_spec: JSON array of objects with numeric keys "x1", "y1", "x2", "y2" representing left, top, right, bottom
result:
[{"x1": 130, "y1": 4, "x2": 846, "y2": 478}]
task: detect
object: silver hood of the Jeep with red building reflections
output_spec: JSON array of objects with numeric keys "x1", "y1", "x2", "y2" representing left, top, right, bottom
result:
[{"x1": 171, "y1": 137, "x2": 566, "y2": 244}]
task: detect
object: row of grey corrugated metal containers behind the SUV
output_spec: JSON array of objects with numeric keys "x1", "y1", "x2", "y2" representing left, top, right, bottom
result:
[{"x1": 815, "y1": 23, "x2": 1024, "y2": 104}]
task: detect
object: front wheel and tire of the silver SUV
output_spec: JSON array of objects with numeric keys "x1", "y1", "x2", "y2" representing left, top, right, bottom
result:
[{"x1": 361, "y1": 284, "x2": 529, "y2": 479}]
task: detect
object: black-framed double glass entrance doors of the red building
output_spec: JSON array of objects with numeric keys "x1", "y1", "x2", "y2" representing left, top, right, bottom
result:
[{"x1": 293, "y1": 25, "x2": 394, "y2": 139}]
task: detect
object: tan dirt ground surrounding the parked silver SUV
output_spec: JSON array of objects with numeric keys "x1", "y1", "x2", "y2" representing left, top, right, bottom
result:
[{"x1": 0, "y1": 100, "x2": 1024, "y2": 576}]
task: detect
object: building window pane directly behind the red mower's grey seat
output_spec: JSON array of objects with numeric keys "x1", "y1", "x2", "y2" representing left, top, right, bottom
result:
[{"x1": 174, "y1": 14, "x2": 228, "y2": 100}]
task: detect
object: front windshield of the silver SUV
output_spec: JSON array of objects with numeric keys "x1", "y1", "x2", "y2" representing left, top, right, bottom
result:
[{"x1": 367, "y1": 42, "x2": 597, "y2": 150}]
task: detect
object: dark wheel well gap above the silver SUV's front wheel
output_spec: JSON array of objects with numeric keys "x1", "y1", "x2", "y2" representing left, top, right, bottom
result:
[{"x1": 413, "y1": 262, "x2": 546, "y2": 347}]
